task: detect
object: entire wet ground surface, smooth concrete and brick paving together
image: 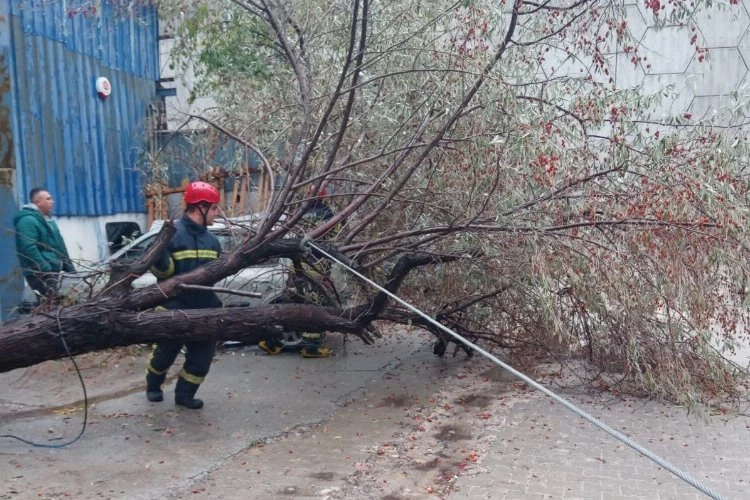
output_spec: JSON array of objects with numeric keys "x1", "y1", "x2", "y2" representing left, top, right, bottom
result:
[{"x1": 0, "y1": 331, "x2": 750, "y2": 500}]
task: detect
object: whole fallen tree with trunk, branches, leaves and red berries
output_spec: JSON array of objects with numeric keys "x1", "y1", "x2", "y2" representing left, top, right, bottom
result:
[{"x1": 0, "y1": 0, "x2": 750, "y2": 410}]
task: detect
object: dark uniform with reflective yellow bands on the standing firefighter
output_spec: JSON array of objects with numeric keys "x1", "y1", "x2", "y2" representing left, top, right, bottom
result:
[{"x1": 146, "y1": 215, "x2": 222, "y2": 408}]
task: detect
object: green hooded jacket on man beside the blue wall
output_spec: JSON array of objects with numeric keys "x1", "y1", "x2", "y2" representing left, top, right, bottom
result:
[{"x1": 13, "y1": 203, "x2": 75, "y2": 276}]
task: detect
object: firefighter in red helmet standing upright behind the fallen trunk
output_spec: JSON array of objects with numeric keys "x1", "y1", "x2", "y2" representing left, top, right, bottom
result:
[{"x1": 146, "y1": 182, "x2": 222, "y2": 410}]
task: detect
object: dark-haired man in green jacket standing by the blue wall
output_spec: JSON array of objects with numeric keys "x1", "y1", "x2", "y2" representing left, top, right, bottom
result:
[{"x1": 13, "y1": 188, "x2": 75, "y2": 296}]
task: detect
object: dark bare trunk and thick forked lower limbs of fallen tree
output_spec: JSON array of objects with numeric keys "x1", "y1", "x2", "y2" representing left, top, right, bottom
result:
[{"x1": 0, "y1": 230, "x2": 482, "y2": 371}]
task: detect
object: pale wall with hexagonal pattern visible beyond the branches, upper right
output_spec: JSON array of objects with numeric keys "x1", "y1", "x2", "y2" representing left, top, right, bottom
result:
[{"x1": 613, "y1": 0, "x2": 750, "y2": 125}]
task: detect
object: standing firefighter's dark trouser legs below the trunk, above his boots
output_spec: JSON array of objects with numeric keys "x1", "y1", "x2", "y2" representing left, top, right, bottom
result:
[{"x1": 148, "y1": 340, "x2": 216, "y2": 385}]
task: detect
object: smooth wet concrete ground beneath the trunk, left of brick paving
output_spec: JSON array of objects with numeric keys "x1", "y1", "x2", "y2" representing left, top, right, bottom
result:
[{"x1": 0, "y1": 332, "x2": 468, "y2": 499}]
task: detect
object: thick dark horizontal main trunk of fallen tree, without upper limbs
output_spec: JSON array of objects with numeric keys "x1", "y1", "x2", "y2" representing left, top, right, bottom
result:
[{"x1": 0, "y1": 304, "x2": 372, "y2": 372}]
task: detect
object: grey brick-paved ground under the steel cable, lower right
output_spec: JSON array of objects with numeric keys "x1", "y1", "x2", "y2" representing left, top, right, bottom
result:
[{"x1": 450, "y1": 393, "x2": 750, "y2": 500}]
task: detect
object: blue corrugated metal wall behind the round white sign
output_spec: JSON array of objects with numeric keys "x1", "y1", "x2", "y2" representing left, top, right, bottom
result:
[{"x1": 6, "y1": 0, "x2": 159, "y2": 216}]
